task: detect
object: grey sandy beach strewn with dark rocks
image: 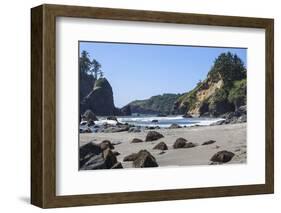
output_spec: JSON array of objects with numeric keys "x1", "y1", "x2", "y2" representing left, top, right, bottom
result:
[{"x1": 80, "y1": 123, "x2": 247, "y2": 168}]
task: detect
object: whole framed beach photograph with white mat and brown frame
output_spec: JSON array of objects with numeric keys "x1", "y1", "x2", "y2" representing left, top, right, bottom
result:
[{"x1": 31, "y1": 5, "x2": 274, "y2": 208}]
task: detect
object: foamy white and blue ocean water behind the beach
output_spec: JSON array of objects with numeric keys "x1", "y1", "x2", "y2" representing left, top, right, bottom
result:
[{"x1": 81, "y1": 115, "x2": 223, "y2": 128}]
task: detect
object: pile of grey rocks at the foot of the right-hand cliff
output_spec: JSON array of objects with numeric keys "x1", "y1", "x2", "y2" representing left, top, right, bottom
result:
[{"x1": 212, "y1": 105, "x2": 247, "y2": 125}]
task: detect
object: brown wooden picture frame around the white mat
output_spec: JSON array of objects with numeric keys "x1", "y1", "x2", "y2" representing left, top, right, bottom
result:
[{"x1": 31, "y1": 5, "x2": 274, "y2": 208}]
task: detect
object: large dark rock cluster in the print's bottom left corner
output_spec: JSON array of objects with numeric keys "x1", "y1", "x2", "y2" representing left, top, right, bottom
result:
[{"x1": 79, "y1": 140, "x2": 123, "y2": 170}]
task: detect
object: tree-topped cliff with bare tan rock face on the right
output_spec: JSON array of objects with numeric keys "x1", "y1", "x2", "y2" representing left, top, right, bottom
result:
[{"x1": 173, "y1": 52, "x2": 247, "y2": 117}]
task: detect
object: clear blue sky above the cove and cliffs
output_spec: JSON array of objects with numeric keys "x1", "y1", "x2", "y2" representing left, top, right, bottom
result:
[{"x1": 79, "y1": 42, "x2": 247, "y2": 107}]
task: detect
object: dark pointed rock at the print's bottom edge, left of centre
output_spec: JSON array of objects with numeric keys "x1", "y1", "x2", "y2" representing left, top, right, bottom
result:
[{"x1": 133, "y1": 150, "x2": 158, "y2": 168}]
